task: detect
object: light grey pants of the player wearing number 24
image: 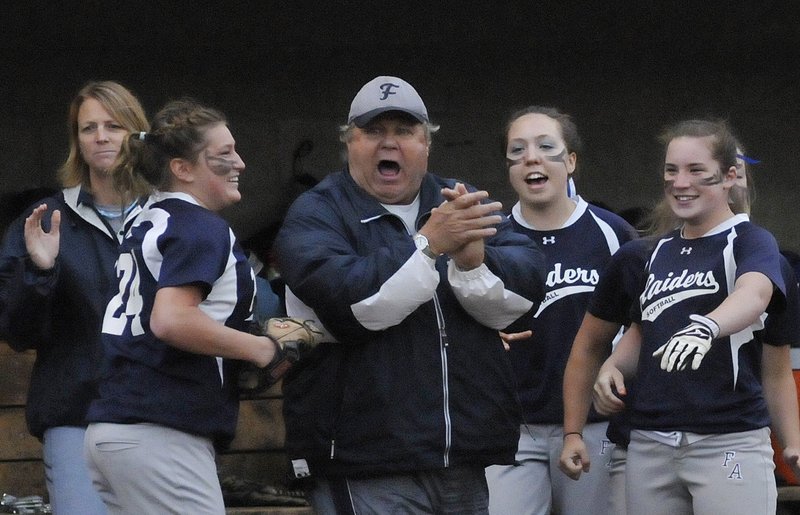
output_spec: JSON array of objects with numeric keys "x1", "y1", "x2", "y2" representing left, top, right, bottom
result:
[{"x1": 84, "y1": 423, "x2": 225, "y2": 515}]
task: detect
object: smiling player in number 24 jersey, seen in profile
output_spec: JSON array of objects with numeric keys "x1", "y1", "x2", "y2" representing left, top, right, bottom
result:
[{"x1": 85, "y1": 101, "x2": 276, "y2": 514}]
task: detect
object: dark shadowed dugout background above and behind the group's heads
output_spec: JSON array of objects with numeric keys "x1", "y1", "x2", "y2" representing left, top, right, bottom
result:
[{"x1": 0, "y1": 0, "x2": 800, "y2": 250}]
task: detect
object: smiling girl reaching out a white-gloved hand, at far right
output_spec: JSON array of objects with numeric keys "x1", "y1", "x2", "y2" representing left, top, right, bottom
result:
[{"x1": 595, "y1": 120, "x2": 800, "y2": 514}]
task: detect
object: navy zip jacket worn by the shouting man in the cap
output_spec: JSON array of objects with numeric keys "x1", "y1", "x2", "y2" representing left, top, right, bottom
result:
[{"x1": 276, "y1": 171, "x2": 544, "y2": 477}]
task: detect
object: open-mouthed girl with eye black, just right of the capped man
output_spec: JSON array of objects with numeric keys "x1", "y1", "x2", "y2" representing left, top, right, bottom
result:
[{"x1": 486, "y1": 106, "x2": 636, "y2": 514}]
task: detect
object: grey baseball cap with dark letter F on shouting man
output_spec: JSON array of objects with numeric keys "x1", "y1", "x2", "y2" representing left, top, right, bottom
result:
[{"x1": 347, "y1": 76, "x2": 428, "y2": 127}]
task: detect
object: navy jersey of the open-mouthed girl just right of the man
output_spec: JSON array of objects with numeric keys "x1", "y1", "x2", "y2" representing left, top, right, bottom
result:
[{"x1": 509, "y1": 198, "x2": 636, "y2": 424}]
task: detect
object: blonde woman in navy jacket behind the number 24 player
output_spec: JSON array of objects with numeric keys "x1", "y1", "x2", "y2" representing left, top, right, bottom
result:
[{"x1": 0, "y1": 81, "x2": 148, "y2": 515}]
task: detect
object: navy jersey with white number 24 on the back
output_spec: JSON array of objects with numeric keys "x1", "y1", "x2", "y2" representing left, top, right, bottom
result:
[{"x1": 89, "y1": 193, "x2": 255, "y2": 445}]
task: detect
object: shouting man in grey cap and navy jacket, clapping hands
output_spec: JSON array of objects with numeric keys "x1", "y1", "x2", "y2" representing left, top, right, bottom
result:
[{"x1": 276, "y1": 77, "x2": 544, "y2": 513}]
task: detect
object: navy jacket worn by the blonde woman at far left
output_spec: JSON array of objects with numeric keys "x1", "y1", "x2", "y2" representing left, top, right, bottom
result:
[{"x1": 0, "y1": 187, "x2": 139, "y2": 438}]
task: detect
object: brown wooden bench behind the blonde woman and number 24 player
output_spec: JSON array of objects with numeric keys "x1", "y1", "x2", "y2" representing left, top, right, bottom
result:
[{"x1": 0, "y1": 341, "x2": 312, "y2": 515}]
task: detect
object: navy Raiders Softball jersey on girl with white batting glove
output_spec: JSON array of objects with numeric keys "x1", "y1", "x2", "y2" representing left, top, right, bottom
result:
[{"x1": 631, "y1": 215, "x2": 785, "y2": 434}]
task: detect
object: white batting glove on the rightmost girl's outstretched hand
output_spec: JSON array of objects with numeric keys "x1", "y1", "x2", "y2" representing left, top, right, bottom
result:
[{"x1": 653, "y1": 315, "x2": 719, "y2": 372}]
